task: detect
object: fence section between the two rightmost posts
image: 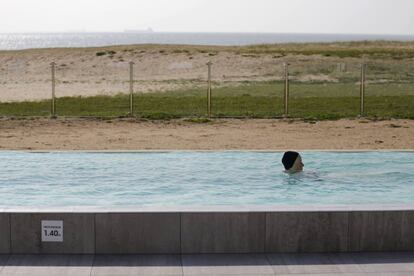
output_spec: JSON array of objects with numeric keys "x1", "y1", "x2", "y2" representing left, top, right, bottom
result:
[{"x1": 289, "y1": 62, "x2": 361, "y2": 118}]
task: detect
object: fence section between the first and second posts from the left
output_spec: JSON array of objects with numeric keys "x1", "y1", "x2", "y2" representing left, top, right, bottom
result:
[{"x1": 56, "y1": 62, "x2": 129, "y2": 117}]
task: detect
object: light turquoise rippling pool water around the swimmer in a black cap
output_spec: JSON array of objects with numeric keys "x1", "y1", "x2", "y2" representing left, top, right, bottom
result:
[{"x1": 0, "y1": 152, "x2": 414, "y2": 208}]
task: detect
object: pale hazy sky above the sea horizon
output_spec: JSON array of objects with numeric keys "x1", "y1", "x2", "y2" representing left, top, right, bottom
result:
[{"x1": 0, "y1": 0, "x2": 414, "y2": 35}]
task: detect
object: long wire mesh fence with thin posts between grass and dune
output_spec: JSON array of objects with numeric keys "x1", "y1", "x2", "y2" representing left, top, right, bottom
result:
[{"x1": 0, "y1": 59, "x2": 414, "y2": 119}]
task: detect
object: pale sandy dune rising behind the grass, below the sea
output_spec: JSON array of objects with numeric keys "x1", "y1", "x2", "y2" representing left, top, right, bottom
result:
[{"x1": 0, "y1": 42, "x2": 414, "y2": 102}]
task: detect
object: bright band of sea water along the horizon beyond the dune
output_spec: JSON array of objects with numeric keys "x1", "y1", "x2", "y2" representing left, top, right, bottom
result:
[{"x1": 0, "y1": 32, "x2": 414, "y2": 50}]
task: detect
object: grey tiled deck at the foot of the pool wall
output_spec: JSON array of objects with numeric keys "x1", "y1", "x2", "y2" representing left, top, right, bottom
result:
[{"x1": 0, "y1": 252, "x2": 414, "y2": 276}]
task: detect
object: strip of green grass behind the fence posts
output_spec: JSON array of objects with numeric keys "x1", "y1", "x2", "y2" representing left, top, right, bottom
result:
[{"x1": 0, "y1": 82, "x2": 414, "y2": 123}]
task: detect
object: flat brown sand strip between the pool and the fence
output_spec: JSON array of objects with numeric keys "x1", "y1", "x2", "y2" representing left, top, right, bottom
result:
[{"x1": 0, "y1": 119, "x2": 414, "y2": 150}]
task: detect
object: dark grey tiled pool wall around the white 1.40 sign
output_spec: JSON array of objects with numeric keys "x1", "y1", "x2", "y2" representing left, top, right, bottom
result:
[{"x1": 0, "y1": 206, "x2": 414, "y2": 254}]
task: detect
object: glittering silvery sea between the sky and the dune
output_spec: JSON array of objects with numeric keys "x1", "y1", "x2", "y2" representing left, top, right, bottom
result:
[{"x1": 0, "y1": 31, "x2": 414, "y2": 52}]
